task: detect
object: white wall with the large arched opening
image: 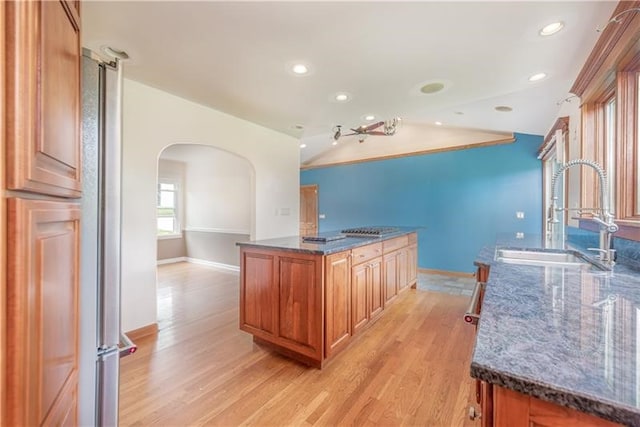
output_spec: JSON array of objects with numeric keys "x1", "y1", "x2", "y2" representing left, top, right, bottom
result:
[{"x1": 122, "y1": 80, "x2": 300, "y2": 331}]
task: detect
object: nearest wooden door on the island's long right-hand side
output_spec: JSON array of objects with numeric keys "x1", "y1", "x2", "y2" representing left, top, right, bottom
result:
[{"x1": 325, "y1": 251, "x2": 351, "y2": 357}]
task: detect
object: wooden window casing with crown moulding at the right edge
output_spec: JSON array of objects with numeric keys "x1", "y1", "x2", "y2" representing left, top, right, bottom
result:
[{"x1": 571, "y1": 1, "x2": 640, "y2": 240}]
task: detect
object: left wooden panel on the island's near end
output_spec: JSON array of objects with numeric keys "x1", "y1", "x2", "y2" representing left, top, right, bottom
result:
[{"x1": 240, "y1": 251, "x2": 278, "y2": 335}]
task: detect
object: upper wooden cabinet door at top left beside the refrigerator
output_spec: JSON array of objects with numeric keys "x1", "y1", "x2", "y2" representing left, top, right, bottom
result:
[{"x1": 6, "y1": 1, "x2": 81, "y2": 197}]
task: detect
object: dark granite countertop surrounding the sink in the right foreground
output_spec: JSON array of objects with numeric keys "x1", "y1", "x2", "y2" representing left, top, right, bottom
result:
[{"x1": 471, "y1": 237, "x2": 640, "y2": 426}]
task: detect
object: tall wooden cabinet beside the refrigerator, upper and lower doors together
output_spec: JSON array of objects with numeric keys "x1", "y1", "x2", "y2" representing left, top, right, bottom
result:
[{"x1": 0, "y1": 1, "x2": 81, "y2": 425}]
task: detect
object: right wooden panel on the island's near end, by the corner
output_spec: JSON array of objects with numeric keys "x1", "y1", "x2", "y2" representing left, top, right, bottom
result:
[{"x1": 278, "y1": 254, "x2": 323, "y2": 360}]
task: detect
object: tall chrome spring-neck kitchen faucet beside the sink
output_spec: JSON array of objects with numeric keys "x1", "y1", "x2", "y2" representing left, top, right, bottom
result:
[{"x1": 548, "y1": 159, "x2": 618, "y2": 269}]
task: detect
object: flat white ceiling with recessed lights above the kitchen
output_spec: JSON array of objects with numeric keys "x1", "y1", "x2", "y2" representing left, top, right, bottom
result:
[{"x1": 82, "y1": 1, "x2": 617, "y2": 160}]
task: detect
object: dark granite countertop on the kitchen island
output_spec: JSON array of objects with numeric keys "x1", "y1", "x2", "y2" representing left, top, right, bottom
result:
[{"x1": 236, "y1": 227, "x2": 419, "y2": 255}]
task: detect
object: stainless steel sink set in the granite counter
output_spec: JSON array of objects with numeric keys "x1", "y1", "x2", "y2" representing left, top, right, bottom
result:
[{"x1": 496, "y1": 248, "x2": 594, "y2": 268}]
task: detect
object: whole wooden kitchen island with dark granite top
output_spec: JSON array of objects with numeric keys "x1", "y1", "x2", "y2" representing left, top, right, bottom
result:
[{"x1": 238, "y1": 227, "x2": 418, "y2": 369}]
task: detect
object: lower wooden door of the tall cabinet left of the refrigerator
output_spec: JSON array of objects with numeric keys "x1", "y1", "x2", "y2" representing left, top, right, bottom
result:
[{"x1": 4, "y1": 198, "x2": 80, "y2": 426}]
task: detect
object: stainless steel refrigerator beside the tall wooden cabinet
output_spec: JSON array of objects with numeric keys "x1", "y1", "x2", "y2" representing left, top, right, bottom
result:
[{"x1": 78, "y1": 49, "x2": 135, "y2": 426}]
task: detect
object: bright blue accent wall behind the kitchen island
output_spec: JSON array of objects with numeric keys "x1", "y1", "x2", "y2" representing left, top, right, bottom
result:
[{"x1": 300, "y1": 134, "x2": 543, "y2": 272}]
